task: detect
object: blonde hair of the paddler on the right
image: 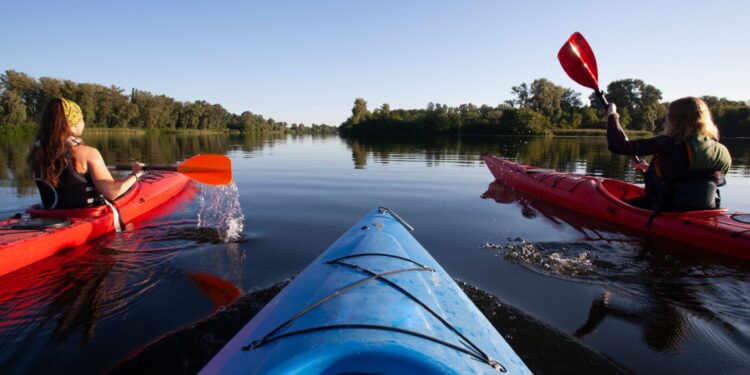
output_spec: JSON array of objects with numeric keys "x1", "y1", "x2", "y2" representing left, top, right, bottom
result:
[{"x1": 664, "y1": 96, "x2": 719, "y2": 141}]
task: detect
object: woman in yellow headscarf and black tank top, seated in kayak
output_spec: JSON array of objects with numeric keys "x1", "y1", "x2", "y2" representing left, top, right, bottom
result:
[{"x1": 28, "y1": 98, "x2": 143, "y2": 209}]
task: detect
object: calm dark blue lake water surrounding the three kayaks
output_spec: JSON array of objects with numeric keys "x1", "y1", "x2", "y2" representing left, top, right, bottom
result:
[{"x1": 0, "y1": 135, "x2": 750, "y2": 373}]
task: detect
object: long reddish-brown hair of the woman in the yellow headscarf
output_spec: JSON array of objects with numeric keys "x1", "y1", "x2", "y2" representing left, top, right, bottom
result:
[{"x1": 27, "y1": 98, "x2": 71, "y2": 187}]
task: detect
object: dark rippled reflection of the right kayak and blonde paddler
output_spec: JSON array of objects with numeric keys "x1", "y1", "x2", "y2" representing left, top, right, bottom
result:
[{"x1": 483, "y1": 181, "x2": 750, "y2": 362}]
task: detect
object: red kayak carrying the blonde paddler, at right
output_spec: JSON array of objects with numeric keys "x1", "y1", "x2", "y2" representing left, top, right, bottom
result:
[{"x1": 484, "y1": 155, "x2": 750, "y2": 259}]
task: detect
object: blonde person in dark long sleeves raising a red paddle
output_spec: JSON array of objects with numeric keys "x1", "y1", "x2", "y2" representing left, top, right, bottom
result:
[{"x1": 607, "y1": 97, "x2": 732, "y2": 212}]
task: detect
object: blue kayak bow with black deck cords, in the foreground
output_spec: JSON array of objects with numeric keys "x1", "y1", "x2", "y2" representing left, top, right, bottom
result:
[{"x1": 202, "y1": 208, "x2": 530, "y2": 374}]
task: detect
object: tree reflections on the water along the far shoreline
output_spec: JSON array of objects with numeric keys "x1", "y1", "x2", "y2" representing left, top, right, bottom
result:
[{"x1": 0, "y1": 133, "x2": 750, "y2": 197}]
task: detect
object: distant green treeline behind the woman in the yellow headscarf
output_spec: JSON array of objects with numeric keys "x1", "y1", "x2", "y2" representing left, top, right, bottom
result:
[{"x1": 0, "y1": 70, "x2": 337, "y2": 134}]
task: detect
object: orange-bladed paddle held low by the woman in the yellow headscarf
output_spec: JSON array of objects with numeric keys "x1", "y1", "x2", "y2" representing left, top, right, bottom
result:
[{"x1": 108, "y1": 154, "x2": 232, "y2": 185}]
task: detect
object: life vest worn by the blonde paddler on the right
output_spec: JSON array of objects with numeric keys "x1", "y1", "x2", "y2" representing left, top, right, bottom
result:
[{"x1": 644, "y1": 134, "x2": 732, "y2": 211}]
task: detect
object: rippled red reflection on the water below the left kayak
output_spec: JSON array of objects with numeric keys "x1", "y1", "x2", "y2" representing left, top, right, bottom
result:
[{"x1": 0, "y1": 220, "x2": 223, "y2": 354}]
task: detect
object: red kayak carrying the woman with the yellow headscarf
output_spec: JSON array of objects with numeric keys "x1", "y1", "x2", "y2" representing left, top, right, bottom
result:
[{"x1": 0, "y1": 172, "x2": 190, "y2": 275}]
